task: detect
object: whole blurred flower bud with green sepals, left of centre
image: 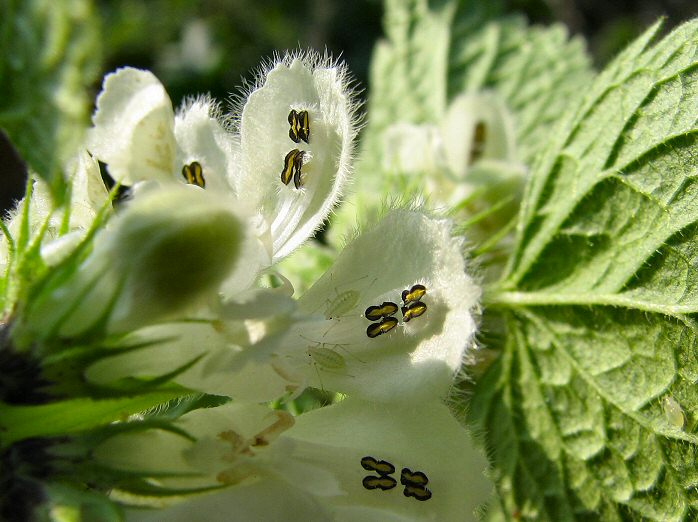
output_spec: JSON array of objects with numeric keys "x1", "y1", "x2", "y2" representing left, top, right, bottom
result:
[{"x1": 14, "y1": 185, "x2": 243, "y2": 344}]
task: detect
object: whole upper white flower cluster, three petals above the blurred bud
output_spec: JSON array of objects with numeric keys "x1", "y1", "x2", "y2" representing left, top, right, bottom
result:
[{"x1": 89, "y1": 55, "x2": 356, "y2": 282}]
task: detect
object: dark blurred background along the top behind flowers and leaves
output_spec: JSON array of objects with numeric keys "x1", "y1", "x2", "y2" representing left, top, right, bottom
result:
[{"x1": 0, "y1": 0, "x2": 698, "y2": 209}]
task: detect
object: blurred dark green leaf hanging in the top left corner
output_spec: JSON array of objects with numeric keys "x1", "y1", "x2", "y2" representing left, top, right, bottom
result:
[{"x1": 0, "y1": 0, "x2": 99, "y2": 193}]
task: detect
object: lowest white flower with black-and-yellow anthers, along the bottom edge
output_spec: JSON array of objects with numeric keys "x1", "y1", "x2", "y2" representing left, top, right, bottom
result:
[{"x1": 96, "y1": 398, "x2": 491, "y2": 522}]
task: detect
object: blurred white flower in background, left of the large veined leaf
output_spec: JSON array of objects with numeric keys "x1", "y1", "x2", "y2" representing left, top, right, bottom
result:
[{"x1": 328, "y1": 92, "x2": 527, "y2": 279}]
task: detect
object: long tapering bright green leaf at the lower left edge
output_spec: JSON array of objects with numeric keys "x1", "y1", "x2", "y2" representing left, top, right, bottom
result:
[{"x1": 0, "y1": 390, "x2": 182, "y2": 446}]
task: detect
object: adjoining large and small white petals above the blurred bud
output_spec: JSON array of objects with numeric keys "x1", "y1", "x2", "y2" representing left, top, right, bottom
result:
[{"x1": 88, "y1": 67, "x2": 234, "y2": 191}]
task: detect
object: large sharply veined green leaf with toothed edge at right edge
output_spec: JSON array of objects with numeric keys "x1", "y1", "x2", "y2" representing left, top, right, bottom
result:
[{"x1": 471, "y1": 20, "x2": 698, "y2": 521}]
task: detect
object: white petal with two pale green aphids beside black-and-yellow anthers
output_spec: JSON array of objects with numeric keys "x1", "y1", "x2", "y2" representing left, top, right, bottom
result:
[{"x1": 268, "y1": 205, "x2": 480, "y2": 401}]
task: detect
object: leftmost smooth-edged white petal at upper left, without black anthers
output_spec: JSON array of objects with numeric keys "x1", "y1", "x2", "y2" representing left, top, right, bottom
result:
[{"x1": 88, "y1": 67, "x2": 175, "y2": 185}]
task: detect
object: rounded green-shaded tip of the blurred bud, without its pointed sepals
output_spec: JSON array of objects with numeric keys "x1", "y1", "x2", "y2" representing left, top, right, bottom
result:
[{"x1": 101, "y1": 187, "x2": 242, "y2": 326}]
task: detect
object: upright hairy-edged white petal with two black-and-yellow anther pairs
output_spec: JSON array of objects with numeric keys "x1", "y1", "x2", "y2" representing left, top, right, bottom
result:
[{"x1": 237, "y1": 54, "x2": 355, "y2": 261}]
